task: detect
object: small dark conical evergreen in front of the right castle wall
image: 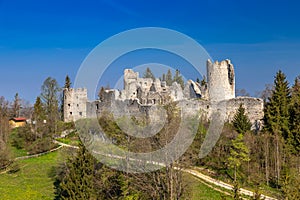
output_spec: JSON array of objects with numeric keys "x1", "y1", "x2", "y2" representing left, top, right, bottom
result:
[{"x1": 232, "y1": 104, "x2": 251, "y2": 134}]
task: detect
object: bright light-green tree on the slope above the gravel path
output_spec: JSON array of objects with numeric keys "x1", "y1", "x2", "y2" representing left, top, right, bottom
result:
[{"x1": 228, "y1": 133, "x2": 250, "y2": 182}]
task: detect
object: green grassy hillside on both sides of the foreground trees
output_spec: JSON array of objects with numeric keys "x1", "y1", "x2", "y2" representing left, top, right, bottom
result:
[{"x1": 0, "y1": 146, "x2": 230, "y2": 200}]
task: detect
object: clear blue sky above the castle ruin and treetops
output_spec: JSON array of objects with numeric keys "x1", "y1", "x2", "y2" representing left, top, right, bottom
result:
[{"x1": 0, "y1": 0, "x2": 300, "y2": 102}]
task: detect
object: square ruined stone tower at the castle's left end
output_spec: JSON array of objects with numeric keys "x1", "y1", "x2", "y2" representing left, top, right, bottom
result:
[{"x1": 63, "y1": 88, "x2": 88, "y2": 122}]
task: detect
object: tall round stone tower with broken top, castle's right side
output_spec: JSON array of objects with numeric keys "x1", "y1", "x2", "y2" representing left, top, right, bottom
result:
[{"x1": 206, "y1": 59, "x2": 235, "y2": 101}]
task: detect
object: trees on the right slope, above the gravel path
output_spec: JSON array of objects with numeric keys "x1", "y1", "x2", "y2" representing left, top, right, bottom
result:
[{"x1": 199, "y1": 71, "x2": 300, "y2": 199}]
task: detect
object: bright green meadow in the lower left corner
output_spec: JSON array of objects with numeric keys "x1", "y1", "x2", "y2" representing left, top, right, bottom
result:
[{"x1": 0, "y1": 152, "x2": 60, "y2": 200}]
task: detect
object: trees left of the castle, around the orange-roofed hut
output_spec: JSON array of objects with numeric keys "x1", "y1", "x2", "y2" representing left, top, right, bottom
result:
[{"x1": 0, "y1": 76, "x2": 73, "y2": 168}]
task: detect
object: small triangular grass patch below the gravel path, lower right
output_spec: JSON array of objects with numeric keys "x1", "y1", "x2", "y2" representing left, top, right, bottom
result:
[{"x1": 184, "y1": 174, "x2": 232, "y2": 200}]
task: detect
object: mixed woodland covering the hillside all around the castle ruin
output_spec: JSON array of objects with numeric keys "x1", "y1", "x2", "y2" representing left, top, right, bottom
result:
[{"x1": 0, "y1": 71, "x2": 300, "y2": 200}]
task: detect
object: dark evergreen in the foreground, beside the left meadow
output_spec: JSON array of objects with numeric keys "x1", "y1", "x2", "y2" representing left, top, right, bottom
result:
[{"x1": 60, "y1": 143, "x2": 95, "y2": 200}]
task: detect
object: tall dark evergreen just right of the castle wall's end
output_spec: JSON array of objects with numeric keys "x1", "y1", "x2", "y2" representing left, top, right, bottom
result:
[{"x1": 265, "y1": 71, "x2": 291, "y2": 140}]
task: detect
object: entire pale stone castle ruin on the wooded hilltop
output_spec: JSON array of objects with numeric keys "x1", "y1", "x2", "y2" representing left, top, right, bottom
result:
[{"x1": 63, "y1": 59, "x2": 264, "y2": 128}]
